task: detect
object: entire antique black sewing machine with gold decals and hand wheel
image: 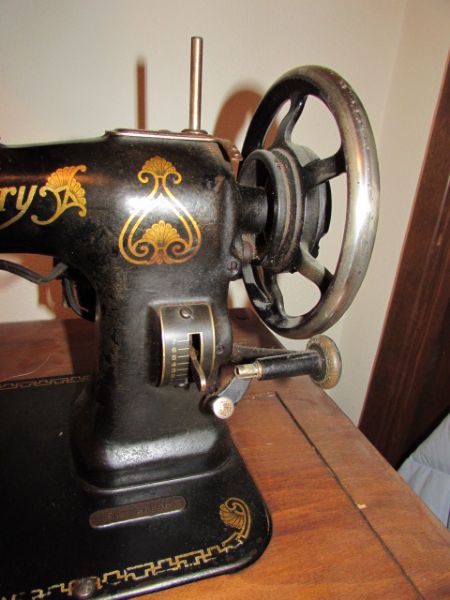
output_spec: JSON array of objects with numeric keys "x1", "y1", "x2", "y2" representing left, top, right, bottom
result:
[{"x1": 0, "y1": 38, "x2": 379, "y2": 599}]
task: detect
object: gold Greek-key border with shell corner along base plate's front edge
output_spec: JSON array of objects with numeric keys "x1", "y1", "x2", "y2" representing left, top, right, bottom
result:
[{"x1": 22, "y1": 498, "x2": 252, "y2": 600}]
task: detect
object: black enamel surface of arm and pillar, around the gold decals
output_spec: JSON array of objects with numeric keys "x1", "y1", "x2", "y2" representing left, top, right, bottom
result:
[{"x1": 0, "y1": 134, "x2": 256, "y2": 487}]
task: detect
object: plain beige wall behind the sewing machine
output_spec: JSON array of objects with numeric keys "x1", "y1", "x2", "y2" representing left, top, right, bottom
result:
[{"x1": 0, "y1": 0, "x2": 450, "y2": 419}]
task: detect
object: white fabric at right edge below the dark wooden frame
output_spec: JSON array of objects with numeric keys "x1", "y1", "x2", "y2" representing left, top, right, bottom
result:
[{"x1": 399, "y1": 415, "x2": 450, "y2": 530}]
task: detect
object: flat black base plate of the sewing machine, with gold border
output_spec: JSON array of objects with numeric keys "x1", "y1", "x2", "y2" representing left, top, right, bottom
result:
[{"x1": 0, "y1": 376, "x2": 270, "y2": 600}]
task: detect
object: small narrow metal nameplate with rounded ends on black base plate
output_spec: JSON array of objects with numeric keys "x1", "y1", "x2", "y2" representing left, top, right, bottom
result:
[{"x1": 89, "y1": 496, "x2": 186, "y2": 529}]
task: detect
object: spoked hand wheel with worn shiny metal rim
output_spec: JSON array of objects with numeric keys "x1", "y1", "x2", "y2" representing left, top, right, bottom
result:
[{"x1": 238, "y1": 66, "x2": 379, "y2": 338}]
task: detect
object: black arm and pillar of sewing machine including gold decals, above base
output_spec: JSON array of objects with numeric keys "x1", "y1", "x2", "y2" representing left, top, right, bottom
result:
[{"x1": 0, "y1": 132, "x2": 264, "y2": 487}]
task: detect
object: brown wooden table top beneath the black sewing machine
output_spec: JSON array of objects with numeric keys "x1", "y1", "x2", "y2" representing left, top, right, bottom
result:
[{"x1": 0, "y1": 310, "x2": 450, "y2": 600}]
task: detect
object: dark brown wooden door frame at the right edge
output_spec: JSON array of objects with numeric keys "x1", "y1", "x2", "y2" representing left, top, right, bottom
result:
[{"x1": 359, "y1": 58, "x2": 450, "y2": 466}]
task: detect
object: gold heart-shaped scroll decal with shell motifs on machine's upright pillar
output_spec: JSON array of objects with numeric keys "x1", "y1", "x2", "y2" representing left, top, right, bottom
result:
[{"x1": 119, "y1": 156, "x2": 202, "y2": 265}]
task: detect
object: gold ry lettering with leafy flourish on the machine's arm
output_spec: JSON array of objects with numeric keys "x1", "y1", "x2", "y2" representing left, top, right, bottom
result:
[{"x1": 0, "y1": 165, "x2": 87, "y2": 229}]
